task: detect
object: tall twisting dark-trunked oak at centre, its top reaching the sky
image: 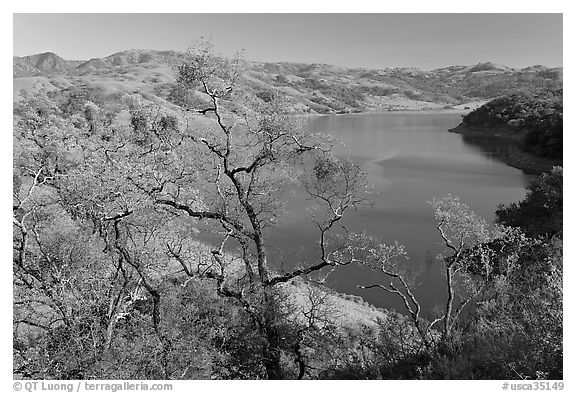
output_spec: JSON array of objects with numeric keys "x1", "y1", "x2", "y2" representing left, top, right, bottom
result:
[{"x1": 150, "y1": 42, "x2": 367, "y2": 379}]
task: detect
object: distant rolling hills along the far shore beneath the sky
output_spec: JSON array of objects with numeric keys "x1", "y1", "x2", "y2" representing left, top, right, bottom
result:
[{"x1": 13, "y1": 50, "x2": 562, "y2": 114}]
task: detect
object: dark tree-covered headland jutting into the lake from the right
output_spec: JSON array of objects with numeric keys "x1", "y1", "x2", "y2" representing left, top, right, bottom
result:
[{"x1": 462, "y1": 89, "x2": 563, "y2": 159}]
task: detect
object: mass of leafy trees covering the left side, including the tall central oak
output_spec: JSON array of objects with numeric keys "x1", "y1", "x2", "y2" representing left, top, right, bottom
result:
[{"x1": 14, "y1": 44, "x2": 374, "y2": 379}]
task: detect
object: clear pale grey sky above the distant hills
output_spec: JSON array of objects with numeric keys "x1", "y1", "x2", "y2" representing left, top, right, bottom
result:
[{"x1": 14, "y1": 14, "x2": 562, "y2": 69}]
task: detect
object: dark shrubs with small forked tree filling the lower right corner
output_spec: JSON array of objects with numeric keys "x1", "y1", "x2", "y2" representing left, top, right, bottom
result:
[{"x1": 352, "y1": 188, "x2": 563, "y2": 379}]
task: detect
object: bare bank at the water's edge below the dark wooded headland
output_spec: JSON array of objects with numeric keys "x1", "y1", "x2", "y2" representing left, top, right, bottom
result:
[{"x1": 448, "y1": 123, "x2": 563, "y2": 175}]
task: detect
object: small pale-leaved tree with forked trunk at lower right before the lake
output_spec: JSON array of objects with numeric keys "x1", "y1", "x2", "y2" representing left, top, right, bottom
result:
[{"x1": 351, "y1": 195, "x2": 496, "y2": 349}]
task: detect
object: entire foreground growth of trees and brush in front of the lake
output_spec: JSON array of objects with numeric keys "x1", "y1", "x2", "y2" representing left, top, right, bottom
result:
[{"x1": 13, "y1": 43, "x2": 563, "y2": 379}]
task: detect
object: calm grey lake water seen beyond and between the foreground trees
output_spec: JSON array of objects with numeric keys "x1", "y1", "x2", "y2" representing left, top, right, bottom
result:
[{"x1": 268, "y1": 113, "x2": 531, "y2": 310}]
